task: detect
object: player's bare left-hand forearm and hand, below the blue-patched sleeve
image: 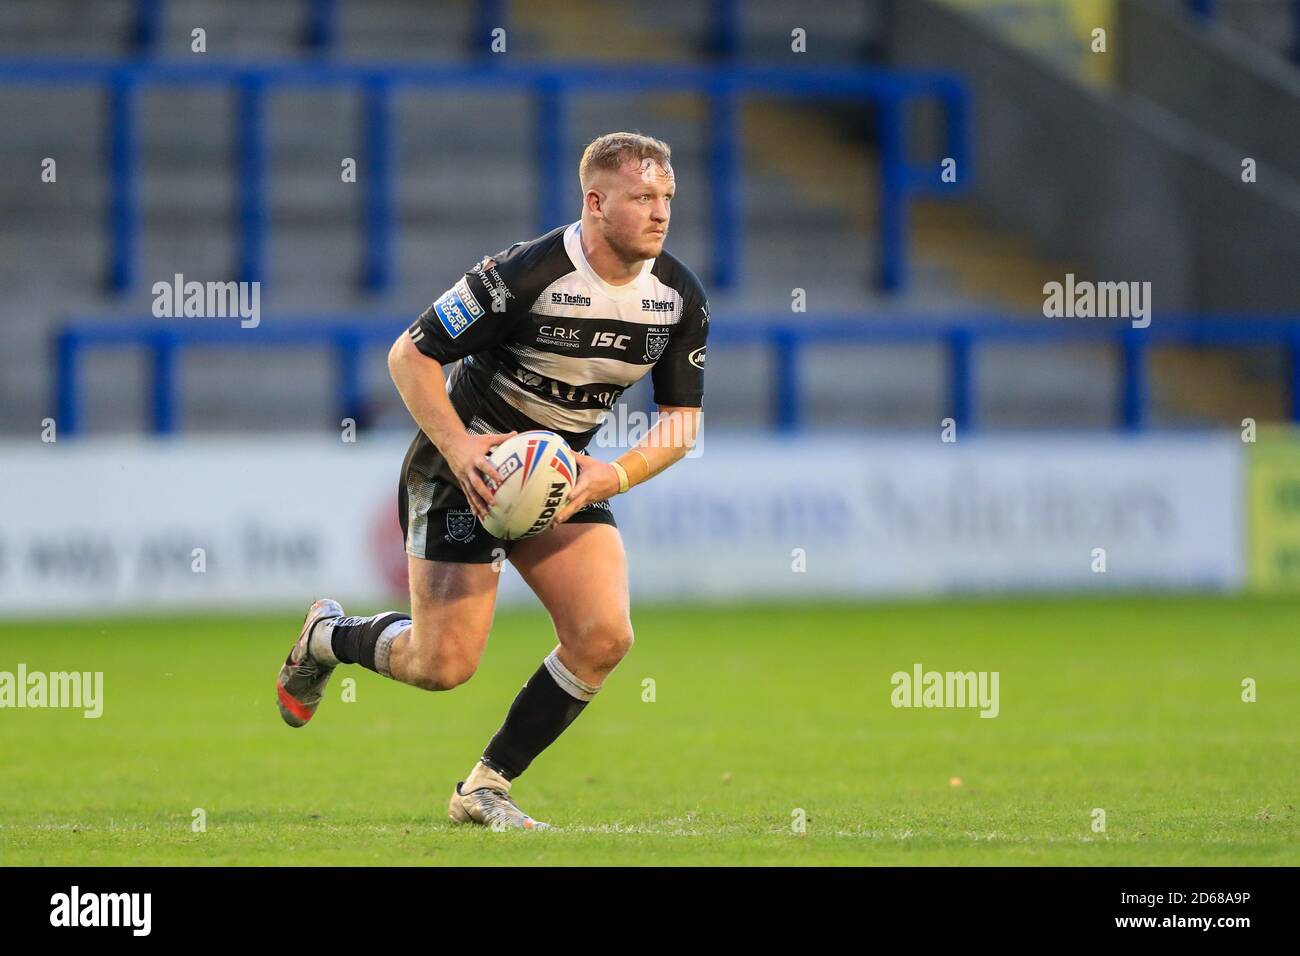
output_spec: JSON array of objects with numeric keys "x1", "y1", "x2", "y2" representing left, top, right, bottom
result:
[{"x1": 389, "y1": 332, "x2": 514, "y2": 516}]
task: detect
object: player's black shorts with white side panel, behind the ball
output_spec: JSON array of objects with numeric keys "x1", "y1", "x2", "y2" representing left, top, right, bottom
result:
[{"x1": 398, "y1": 444, "x2": 619, "y2": 564}]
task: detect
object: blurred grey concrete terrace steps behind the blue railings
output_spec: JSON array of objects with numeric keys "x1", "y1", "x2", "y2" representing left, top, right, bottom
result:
[{"x1": 0, "y1": 0, "x2": 1242, "y2": 433}]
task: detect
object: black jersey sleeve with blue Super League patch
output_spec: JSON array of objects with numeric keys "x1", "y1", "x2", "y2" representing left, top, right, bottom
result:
[{"x1": 408, "y1": 252, "x2": 528, "y2": 364}]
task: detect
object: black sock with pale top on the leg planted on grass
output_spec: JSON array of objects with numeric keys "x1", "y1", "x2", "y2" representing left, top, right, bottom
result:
[{"x1": 482, "y1": 654, "x2": 598, "y2": 780}]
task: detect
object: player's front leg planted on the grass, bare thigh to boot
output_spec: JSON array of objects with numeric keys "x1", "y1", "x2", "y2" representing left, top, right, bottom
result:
[{"x1": 451, "y1": 507, "x2": 633, "y2": 826}]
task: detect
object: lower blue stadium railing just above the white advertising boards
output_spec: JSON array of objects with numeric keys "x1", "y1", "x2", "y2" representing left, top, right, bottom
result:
[{"x1": 53, "y1": 313, "x2": 1300, "y2": 434}]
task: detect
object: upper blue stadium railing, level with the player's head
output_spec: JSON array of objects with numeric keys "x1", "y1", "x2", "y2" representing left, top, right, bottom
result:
[{"x1": 0, "y1": 60, "x2": 972, "y2": 293}]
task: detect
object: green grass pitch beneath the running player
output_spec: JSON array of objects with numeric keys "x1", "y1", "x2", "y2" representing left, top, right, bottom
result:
[{"x1": 0, "y1": 597, "x2": 1300, "y2": 865}]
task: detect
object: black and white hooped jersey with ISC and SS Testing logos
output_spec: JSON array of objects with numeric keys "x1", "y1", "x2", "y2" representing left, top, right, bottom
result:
[{"x1": 408, "y1": 222, "x2": 709, "y2": 475}]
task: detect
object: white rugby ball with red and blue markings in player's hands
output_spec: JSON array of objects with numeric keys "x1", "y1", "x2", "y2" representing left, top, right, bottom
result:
[{"x1": 480, "y1": 429, "x2": 577, "y2": 541}]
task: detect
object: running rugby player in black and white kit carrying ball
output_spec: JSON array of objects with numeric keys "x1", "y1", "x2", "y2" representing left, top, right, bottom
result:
[{"x1": 269, "y1": 133, "x2": 709, "y2": 829}]
